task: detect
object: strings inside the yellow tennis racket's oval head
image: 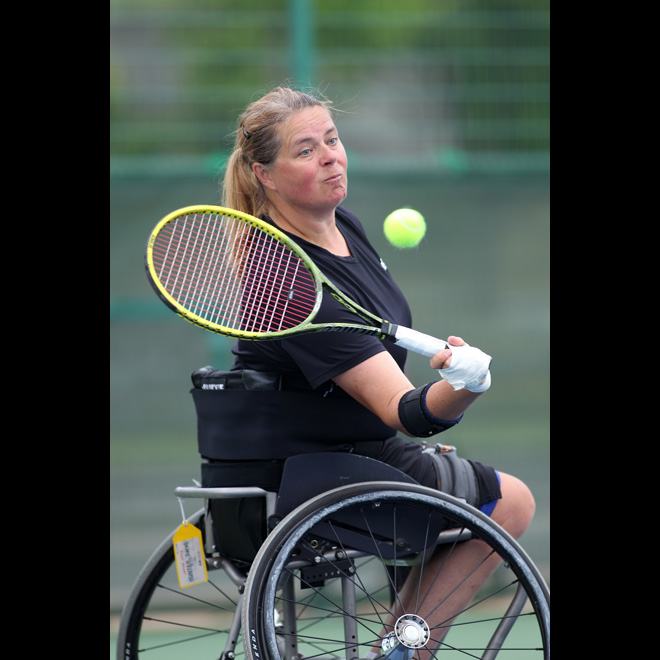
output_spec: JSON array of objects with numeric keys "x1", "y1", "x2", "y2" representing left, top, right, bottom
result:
[{"x1": 152, "y1": 213, "x2": 316, "y2": 332}]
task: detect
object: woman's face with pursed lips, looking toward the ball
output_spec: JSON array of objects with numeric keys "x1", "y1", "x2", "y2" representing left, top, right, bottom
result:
[{"x1": 255, "y1": 106, "x2": 348, "y2": 213}]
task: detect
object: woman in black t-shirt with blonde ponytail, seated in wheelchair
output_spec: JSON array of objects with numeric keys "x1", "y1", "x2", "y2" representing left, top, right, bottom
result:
[{"x1": 223, "y1": 88, "x2": 535, "y2": 653}]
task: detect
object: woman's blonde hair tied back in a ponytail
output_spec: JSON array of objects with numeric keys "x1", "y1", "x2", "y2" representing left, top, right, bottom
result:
[{"x1": 222, "y1": 87, "x2": 331, "y2": 218}]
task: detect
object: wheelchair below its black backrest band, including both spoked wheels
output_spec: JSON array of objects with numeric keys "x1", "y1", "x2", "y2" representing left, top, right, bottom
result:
[{"x1": 117, "y1": 452, "x2": 550, "y2": 660}]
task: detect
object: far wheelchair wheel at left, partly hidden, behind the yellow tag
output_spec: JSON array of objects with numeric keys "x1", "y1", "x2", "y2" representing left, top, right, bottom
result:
[{"x1": 117, "y1": 509, "x2": 247, "y2": 660}]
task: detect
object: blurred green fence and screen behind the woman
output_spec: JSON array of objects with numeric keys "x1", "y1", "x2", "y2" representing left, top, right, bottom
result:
[{"x1": 110, "y1": 0, "x2": 550, "y2": 640}]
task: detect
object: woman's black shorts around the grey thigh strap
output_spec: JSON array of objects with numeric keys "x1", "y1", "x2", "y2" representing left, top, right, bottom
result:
[{"x1": 353, "y1": 436, "x2": 502, "y2": 515}]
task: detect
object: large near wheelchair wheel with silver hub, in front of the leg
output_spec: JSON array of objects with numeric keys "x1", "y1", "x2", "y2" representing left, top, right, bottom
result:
[{"x1": 242, "y1": 482, "x2": 550, "y2": 660}]
